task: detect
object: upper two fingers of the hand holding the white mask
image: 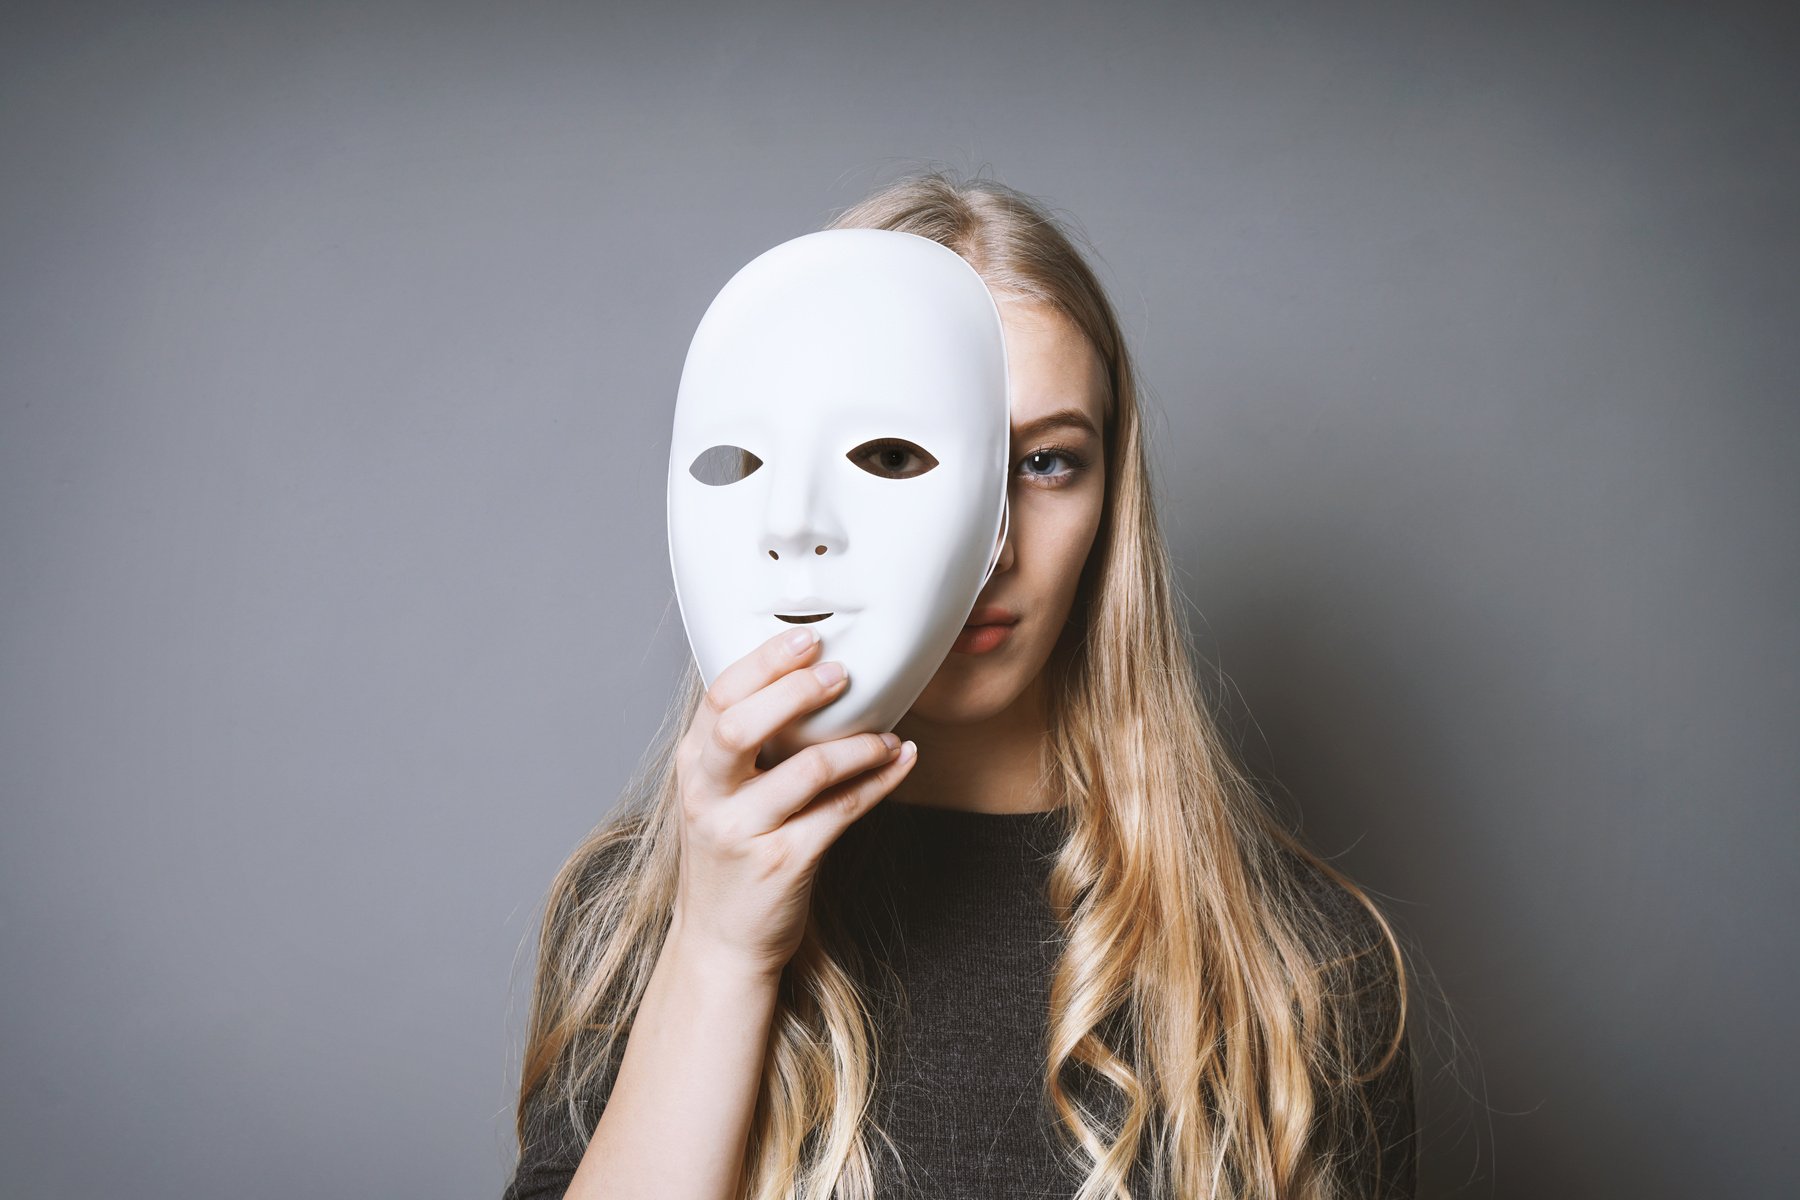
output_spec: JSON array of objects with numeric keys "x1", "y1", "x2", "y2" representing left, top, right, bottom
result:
[{"x1": 689, "y1": 628, "x2": 846, "y2": 793}]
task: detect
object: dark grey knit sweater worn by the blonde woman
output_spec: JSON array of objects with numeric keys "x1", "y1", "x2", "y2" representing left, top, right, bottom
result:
[{"x1": 502, "y1": 801, "x2": 1417, "y2": 1200}]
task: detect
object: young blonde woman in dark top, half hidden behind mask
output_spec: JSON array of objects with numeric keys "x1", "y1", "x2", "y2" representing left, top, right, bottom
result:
[{"x1": 506, "y1": 173, "x2": 1417, "y2": 1200}]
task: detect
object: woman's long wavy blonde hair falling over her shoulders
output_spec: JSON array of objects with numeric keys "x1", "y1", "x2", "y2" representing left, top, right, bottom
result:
[{"x1": 517, "y1": 171, "x2": 1406, "y2": 1200}]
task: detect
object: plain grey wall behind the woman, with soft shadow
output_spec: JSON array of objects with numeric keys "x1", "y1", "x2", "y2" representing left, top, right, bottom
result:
[{"x1": 0, "y1": 4, "x2": 1800, "y2": 1198}]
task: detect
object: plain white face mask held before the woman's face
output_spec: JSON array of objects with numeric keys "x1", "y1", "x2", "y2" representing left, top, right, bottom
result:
[{"x1": 668, "y1": 228, "x2": 1012, "y2": 759}]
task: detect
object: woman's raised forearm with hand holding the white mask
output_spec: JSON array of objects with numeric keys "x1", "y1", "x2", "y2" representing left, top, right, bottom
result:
[{"x1": 506, "y1": 631, "x2": 916, "y2": 1200}]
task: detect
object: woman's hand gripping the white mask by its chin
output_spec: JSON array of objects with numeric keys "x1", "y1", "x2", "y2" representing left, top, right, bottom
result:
[{"x1": 671, "y1": 630, "x2": 918, "y2": 977}]
